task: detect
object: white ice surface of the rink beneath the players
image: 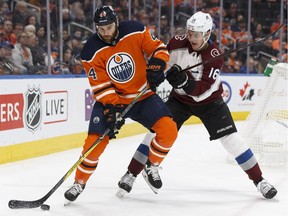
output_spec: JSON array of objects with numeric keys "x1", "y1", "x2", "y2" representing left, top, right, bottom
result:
[{"x1": 0, "y1": 125, "x2": 288, "y2": 216}]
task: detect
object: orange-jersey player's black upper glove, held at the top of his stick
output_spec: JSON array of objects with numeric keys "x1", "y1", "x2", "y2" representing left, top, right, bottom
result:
[{"x1": 146, "y1": 57, "x2": 166, "y2": 92}]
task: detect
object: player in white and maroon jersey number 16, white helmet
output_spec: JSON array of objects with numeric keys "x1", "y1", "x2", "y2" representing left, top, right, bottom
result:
[{"x1": 118, "y1": 11, "x2": 277, "y2": 199}]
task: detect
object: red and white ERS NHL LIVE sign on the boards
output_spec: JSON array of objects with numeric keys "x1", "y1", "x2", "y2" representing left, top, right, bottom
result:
[{"x1": 0, "y1": 86, "x2": 68, "y2": 132}]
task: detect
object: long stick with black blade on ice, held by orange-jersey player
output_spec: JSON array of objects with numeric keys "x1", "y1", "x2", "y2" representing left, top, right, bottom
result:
[{"x1": 8, "y1": 86, "x2": 149, "y2": 209}]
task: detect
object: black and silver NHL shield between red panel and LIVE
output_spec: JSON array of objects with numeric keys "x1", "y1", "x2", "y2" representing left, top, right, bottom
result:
[{"x1": 25, "y1": 87, "x2": 42, "y2": 131}]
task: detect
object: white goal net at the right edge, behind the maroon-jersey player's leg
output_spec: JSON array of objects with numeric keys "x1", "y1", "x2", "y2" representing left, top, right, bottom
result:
[{"x1": 239, "y1": 63, "x2": 288, "y2": 166}]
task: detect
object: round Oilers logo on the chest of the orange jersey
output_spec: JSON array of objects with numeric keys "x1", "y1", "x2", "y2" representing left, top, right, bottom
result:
[{"x1": 106, "y1": 53, "x2": 135, "y2": 83}]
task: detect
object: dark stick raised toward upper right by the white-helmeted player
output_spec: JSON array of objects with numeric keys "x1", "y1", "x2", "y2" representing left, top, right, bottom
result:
[{"x1": 181, "y1": 21, "x2": 286, "y2": 73}]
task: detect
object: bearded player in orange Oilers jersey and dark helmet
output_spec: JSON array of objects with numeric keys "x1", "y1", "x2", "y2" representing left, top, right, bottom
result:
[{"x1": 64, "y1": 6, "x2": 177, "y2": 204}]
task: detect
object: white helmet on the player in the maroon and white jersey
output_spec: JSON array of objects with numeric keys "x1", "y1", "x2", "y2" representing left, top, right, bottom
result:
[{"x1": 186, "y1": 11, "x2": 213, "y2": 33}]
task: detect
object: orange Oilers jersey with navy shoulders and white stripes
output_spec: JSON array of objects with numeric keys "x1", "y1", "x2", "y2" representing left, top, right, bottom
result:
[{"x1": 81, "y1": 21, "x2": 169, "y2": 105}]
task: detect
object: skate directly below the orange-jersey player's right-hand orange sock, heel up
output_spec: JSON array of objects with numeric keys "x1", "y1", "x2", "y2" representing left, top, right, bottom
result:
[{"x1": 142, "y1": 161, "x2": 162, "y2": 194}]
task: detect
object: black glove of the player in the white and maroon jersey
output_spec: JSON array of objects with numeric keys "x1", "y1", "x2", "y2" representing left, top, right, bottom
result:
[{"x1": 166, "y1": 64, "x2": 195, "y2": 94}]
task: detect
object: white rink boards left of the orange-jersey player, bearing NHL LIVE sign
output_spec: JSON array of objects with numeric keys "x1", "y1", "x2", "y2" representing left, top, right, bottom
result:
[{"x1": 0, "y1": 75, "x2": 90, "y2": 147}]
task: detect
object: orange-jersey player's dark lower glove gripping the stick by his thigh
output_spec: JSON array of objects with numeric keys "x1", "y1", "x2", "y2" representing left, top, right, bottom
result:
[{"x1": 104, "y1": 104, "x2": 125, "y2": 139}]
